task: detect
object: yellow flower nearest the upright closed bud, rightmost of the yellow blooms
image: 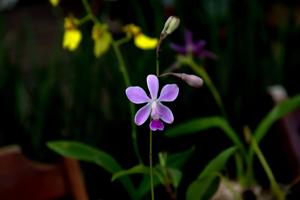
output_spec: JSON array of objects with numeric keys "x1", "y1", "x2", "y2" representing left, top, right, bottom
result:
[{"x1": 123, "y1": 24, "x2": 158, "y2": 50}]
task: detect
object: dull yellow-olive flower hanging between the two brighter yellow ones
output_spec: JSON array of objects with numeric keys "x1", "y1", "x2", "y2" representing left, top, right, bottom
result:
[{"x1": 92, "y1": 23, "x2": 112, "y2": 58}]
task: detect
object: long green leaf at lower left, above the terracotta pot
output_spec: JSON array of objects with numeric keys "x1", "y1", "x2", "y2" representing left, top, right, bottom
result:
[{"x1": 47, "y1": 140, "x2": 136, "y2": 199}]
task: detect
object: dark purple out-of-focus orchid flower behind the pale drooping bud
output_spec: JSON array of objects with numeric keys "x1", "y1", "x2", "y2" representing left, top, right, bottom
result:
[{"x1": 170, "y1": 30, "x2": 216, "y2": 59}]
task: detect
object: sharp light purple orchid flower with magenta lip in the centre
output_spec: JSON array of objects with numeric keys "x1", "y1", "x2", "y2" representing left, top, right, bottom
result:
[{"x1": 125, "y1": 75, "x2": 179, "y2": 131}]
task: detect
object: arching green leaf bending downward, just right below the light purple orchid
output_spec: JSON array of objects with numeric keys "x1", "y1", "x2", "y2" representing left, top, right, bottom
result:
[{"x1": 165, "y1": 116, "x2": 243, "y2": 147}]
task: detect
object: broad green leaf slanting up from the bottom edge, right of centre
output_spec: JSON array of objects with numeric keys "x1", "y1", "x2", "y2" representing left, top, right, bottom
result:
[{"x1": 186, "y1": 147, "x2": 237, "y2": 200}]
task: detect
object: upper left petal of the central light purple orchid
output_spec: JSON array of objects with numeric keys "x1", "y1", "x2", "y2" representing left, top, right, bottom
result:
[{"x1": 125, "y1": 86, "x2": 150, "y2": 104}]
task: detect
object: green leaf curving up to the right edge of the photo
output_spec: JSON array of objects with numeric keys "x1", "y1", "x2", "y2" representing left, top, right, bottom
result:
[{"x1": 253, "y1": 95, "x2": 300, "y2": 144}]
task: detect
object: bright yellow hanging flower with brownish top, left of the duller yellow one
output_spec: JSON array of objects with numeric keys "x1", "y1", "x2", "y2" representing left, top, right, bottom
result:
[{"x1": 63, "y1": 17, "x2": 82, "y2": 51}]
